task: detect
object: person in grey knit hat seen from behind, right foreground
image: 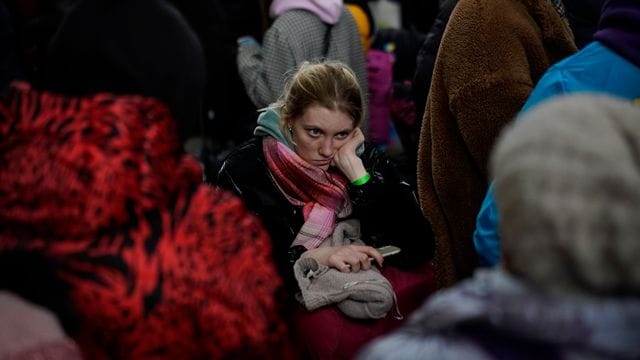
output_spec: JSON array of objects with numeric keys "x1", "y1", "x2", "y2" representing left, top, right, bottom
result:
[{"x1": 358, "y1": 94, "x2": 640, "y2": 360}]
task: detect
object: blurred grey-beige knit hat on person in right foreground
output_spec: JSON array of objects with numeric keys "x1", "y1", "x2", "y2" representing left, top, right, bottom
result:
[{"x1": 491, "y1": 94, "x2": 640, "y2": 295}]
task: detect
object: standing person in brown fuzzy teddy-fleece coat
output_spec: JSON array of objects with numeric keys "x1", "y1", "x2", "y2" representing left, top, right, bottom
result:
[{"x1": 417, "y1": 0, "x2": 577, "y2": 287}]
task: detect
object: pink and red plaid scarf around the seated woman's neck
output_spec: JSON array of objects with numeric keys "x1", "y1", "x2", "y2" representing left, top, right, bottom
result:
[{"x1": 262, "y1": 136, "x2": 351, "y2": 249}]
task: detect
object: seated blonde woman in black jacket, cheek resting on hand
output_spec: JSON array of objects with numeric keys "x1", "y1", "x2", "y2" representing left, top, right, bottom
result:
[{"x1": 218, "y1": 62, "x2": 433, "y2": 358}]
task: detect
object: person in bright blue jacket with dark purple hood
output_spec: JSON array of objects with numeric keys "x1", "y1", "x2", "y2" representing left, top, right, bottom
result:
[{"x1": 473, "y1": 0, "x2": 640, "y2": 266}]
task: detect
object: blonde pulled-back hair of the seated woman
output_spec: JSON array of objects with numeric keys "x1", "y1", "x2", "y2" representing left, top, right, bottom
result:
[{"x1": 275, "y1": 61, "x2": 364, "y2": 140}]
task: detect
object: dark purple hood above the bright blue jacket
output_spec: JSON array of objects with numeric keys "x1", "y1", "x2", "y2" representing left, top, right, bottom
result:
[{"x1": 594, "y1": 0, "x2": 640, "y2": 67}]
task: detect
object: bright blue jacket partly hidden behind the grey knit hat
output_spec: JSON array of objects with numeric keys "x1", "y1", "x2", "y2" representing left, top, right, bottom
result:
[{"x1": 473, "y1": 41, "x2": 640, "y2": 266}]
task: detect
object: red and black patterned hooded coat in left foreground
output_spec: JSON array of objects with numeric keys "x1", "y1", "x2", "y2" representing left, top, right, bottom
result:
[{"x1": 0, "y1": 83, "x2": 294, "y2": 359}]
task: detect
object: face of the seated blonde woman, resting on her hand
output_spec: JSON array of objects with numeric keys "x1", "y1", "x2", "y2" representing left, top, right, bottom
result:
[{"x1": 290, "y1": 105, "x2": 355, "y2": 170}]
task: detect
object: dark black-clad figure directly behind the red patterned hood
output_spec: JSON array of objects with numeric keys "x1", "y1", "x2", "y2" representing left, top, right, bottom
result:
[{"x1": 41, "y1": 0, "x2": 207, "y2": 147}]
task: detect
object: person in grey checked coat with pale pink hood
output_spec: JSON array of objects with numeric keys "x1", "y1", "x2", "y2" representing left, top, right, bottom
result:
[{"x1": 237, "y1": 0, "x2": 368, "y2": 135}]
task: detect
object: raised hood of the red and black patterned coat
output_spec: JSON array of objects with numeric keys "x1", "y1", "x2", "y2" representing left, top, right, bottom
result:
[{"x1": 0, "y1": 83, "x2": 202, "y2": 239}]
